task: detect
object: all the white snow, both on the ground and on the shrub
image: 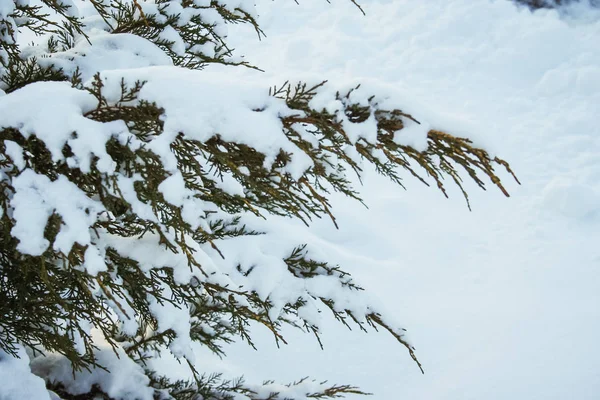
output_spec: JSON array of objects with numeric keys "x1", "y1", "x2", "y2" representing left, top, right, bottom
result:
[{"x1": 0, "y1": 0, "x2": 600, "y2": 400}]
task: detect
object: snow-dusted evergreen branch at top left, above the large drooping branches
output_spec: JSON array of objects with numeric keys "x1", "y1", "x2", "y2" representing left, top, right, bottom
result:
[{"x1": 0, "y1": 0, "x2": 257, "y2": 93}]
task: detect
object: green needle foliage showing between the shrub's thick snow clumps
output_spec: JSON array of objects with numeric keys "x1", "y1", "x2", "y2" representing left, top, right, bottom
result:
[{"x1": 0, "y1": 0, "x2": 512, "y2": 400}]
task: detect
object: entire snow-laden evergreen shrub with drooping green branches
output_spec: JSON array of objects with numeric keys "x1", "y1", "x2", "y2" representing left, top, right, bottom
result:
[{"x1": 0, "y1": 0, "x2": 510, "y2": 399}]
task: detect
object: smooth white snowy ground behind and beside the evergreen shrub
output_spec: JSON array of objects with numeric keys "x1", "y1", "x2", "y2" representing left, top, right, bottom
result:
[{"x1": 185, "y1": 0, "x2": 600, "y2": 400}]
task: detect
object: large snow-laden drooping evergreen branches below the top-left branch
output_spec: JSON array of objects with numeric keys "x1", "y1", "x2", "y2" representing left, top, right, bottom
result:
[{"x1": 0, "y1": 68, "x2": 510, "y2": 396}]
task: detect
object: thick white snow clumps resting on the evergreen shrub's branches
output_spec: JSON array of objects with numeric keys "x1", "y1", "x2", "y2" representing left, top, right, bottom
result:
[{"x1": 0, "y1": 1, "x2": 426, "y2": 399}]
